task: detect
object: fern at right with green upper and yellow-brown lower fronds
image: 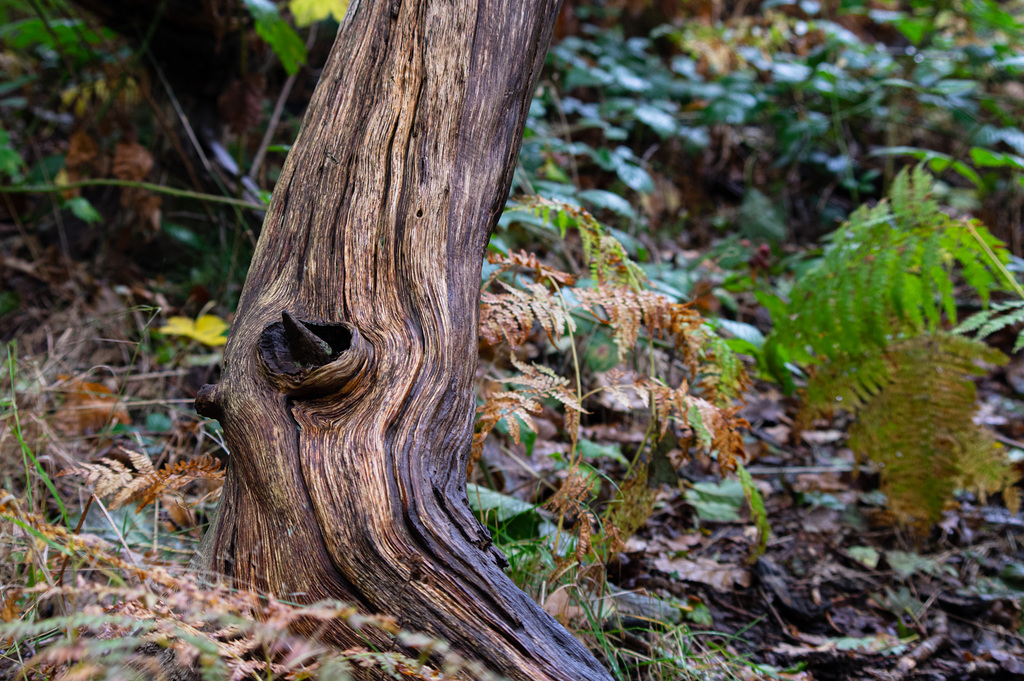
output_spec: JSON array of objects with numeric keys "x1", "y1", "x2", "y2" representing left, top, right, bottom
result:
[{"x1": 761, "y1": 167, "x2": 1017, "y2": 528}]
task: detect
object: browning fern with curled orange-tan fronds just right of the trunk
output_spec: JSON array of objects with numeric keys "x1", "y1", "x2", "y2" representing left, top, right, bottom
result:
[{"x1": 472, "y1": 198, "x2": 748, "y2": 560}]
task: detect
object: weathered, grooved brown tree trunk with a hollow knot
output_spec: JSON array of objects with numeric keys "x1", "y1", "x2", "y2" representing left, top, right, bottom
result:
[{"x1": 196, "y1": 0, "x2": 610, "y2": 681}]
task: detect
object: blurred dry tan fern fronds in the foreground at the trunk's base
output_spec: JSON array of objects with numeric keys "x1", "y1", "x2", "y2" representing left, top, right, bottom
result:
[{"x1": 0, "y1": 495, "x2": 507, "y2": 681}]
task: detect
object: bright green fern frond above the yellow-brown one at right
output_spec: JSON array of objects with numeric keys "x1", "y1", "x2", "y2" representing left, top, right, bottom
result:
[{"x1": 772, "y1": 168, "x2": 1009, "y2": 361}]
